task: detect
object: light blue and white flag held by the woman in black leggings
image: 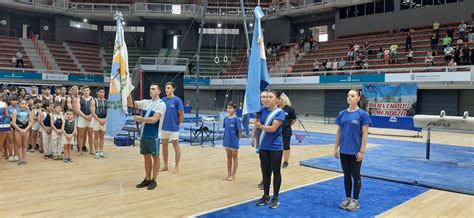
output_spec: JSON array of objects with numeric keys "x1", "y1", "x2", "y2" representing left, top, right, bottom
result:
[{"x1": 243, "y1": 6, "x2": 270, "y2": 114}]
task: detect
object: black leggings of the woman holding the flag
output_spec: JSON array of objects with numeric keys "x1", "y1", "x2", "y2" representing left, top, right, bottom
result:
[{"x1": 259, "y1": 150, "x2": 283, "y2": 197}]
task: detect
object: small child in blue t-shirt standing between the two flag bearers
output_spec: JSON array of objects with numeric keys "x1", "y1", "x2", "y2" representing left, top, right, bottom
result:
[{"x1": 223, "y1": 102, "x2": 242, "y2": 181}]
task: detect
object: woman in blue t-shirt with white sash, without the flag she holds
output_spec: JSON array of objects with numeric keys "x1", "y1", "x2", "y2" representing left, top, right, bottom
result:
[{"x1": 254, "y1": 90, "x2": 285, "y2": 208}]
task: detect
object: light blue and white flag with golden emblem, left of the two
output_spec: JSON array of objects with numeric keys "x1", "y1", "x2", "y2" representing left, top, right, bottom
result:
[{"x1": 106, "y1": 12, "x2": 134, "y2": 137}]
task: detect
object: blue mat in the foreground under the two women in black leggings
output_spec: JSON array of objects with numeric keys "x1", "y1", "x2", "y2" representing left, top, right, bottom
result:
[{"x1": 201, "y1": 177, "x2": 428, "y2": 217}]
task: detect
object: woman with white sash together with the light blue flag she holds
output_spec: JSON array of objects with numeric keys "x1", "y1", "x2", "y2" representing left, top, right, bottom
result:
[{"x1": 243, "y1": 6, "x2": 285, "y2": 208}]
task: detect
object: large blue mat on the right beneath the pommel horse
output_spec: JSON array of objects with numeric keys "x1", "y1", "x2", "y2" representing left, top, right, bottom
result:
[{"x1": 300, "y1": 132, "x2": 474, "y2": 195}]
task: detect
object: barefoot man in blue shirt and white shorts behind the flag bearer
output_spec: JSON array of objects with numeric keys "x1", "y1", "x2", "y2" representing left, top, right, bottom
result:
[{"x1": 161, "y1": 82, "x2": 184, "y2": 174}]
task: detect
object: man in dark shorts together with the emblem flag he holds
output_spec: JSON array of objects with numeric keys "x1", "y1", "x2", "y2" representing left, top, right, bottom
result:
[{"x1": 106, "y1": 12, "x2": 166, "y2": 190}]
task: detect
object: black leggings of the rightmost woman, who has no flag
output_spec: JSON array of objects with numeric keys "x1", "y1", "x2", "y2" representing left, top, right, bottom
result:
[{"x1": 341, "y1": 154, "x2": 362, "y2": 199}]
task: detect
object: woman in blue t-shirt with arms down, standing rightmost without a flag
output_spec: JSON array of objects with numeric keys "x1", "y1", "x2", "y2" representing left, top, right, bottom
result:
[{"x1": 334, "y1": 90, "x2": 371, "y2": 211}]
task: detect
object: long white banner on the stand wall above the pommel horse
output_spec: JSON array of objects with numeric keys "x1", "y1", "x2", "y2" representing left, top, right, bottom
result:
[{"x1": 385, "y1": 72, "x2": 471, "y2": 82}]
